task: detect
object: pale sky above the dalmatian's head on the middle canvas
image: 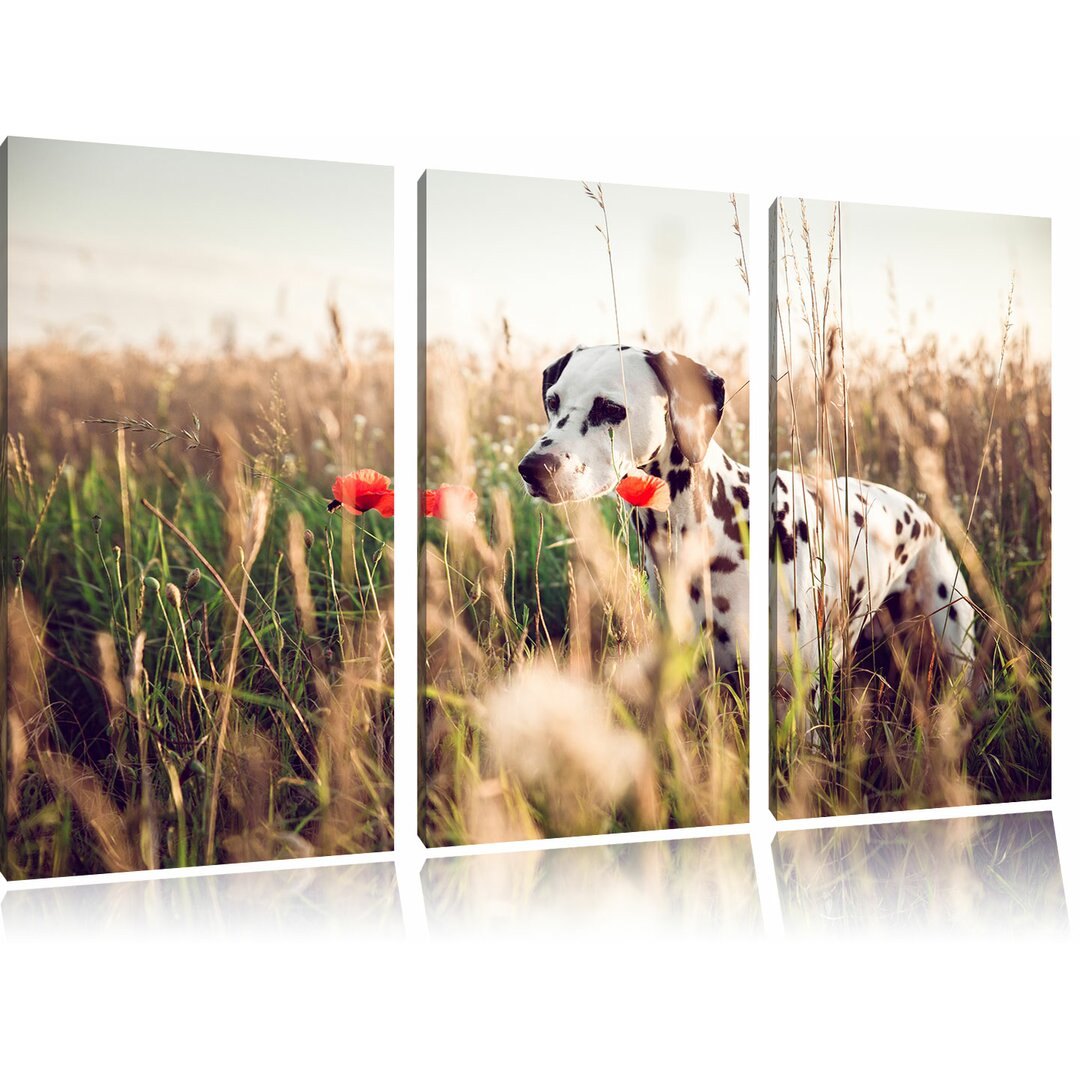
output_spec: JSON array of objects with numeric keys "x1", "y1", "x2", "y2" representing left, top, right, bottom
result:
[{"x1": 427, "y1": 172, "x2": 751, "y2": 365}]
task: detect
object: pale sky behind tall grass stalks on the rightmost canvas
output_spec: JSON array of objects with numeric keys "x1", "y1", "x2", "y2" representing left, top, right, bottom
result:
[{"x1": 778, "y1": 198, "x2": 1050, "y2": 360}]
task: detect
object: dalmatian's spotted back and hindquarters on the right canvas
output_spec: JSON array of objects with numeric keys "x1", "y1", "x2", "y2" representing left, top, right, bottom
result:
[{"x1": 769, "y1": 471, "x2": 975, "y2": 745}]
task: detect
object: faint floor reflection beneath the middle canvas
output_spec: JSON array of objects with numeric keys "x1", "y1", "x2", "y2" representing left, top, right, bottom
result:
[{"x1": 421, "y1": 835, "x2": 761, "y2": 936}]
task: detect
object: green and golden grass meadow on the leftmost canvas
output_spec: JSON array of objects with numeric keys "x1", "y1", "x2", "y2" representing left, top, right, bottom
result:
[{"x1": 0, "y1": 324, "x2": 393, "y2": 879}]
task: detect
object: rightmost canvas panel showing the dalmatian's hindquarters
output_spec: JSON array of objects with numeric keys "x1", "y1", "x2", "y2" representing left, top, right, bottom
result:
[{"x1": 769, "y1": 198, "x2": 1051, "y2": 819}]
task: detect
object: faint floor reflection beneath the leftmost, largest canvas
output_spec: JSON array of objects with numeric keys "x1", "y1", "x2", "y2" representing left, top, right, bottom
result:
[{"x1": 0, "y1": 861, "x2": 402, "y2": 940}]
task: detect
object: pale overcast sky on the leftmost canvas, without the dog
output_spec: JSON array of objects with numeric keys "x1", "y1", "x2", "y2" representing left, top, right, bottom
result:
[{"x1": 9, "y1": 138, "x2": 393, "y2": 353}]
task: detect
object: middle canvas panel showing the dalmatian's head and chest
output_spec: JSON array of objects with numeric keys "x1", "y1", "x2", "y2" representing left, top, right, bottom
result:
[{"x1": 419, "y1": 172, "x2": 750, "y2": 846}]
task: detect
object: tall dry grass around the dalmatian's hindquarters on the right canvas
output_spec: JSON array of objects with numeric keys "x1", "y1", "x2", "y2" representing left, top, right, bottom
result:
[{"x1": 771, "y1": 203, "x2": 1051, "y2": 818}]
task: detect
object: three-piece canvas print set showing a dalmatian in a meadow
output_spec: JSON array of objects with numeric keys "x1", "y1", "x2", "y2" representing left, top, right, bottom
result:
[{"x1": 0, "y1": 139, "x2": 1051, "y2": 879}]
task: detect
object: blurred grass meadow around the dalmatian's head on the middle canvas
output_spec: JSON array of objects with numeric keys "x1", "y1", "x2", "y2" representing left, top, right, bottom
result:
[{"x1": 419, "y1": 332, "x2": 748, "y2": 846}]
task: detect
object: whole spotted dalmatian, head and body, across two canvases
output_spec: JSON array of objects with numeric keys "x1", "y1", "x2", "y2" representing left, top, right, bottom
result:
[{"x1": 518, "y1": 345, "x2": 973, "y2": 721}]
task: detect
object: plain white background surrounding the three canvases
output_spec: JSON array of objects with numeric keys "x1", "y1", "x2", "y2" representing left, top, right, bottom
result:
[{"x1": 0, "y1": 0, "x2": 1080, "y2": 1075}]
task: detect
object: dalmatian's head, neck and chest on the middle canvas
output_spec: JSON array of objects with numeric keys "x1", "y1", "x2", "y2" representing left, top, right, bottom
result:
[{"x1": 517, "y1": 345, "x2": 750, "y2": 675}]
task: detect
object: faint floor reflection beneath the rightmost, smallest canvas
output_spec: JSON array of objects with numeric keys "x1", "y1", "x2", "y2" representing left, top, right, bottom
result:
[{"x1": 773, "y1": 812, "x2": 1068, "y2": 934}]
